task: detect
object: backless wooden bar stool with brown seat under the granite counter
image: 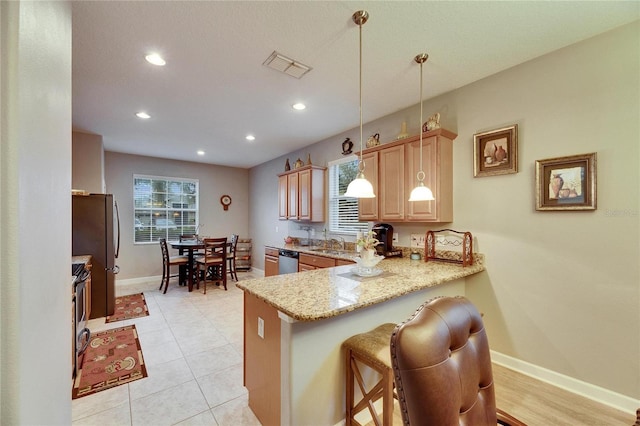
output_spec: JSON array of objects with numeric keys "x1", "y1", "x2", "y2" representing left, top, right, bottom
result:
[{"x1": 342, "y1": 323, "x2": 396, "y2": 426}]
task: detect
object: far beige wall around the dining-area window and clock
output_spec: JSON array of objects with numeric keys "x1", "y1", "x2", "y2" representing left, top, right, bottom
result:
[{"x1": 105, "y1": 151, "x2": 251, "y2": 285}]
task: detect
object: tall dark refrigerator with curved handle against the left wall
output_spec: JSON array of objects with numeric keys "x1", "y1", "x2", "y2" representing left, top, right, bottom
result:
[{"x1": 71, "y1": 194, "x2": 120, "y2": 319}]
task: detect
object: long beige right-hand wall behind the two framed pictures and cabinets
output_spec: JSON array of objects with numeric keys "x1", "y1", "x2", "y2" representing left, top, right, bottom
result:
[{"x1": 250, "y1": 22, "x2": 640, "y2": 402}]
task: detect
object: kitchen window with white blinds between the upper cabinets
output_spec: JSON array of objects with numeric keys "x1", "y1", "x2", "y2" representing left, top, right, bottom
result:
[{"x1": 329, "y1": 157, "x2": 368, "y2": 234}]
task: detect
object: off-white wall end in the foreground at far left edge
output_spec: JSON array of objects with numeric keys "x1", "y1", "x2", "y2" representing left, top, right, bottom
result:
[{"x1": 0, "y1": 1, "x2": 72, "y2": 425}]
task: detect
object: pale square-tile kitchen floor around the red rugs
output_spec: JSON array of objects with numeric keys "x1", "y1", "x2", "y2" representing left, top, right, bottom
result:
[{"x1": 72, "y1": 272, "x2": 260, "y2": 426}]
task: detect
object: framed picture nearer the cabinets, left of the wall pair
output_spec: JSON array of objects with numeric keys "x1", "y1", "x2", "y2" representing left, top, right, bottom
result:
[{"x1": 473, "y1": 124, "x2": 518, "y2": 177}]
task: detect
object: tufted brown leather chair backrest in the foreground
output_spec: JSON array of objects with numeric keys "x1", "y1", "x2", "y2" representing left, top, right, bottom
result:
[{"x1": 391, "y1": 297, "x2": 497, "y2": 425}]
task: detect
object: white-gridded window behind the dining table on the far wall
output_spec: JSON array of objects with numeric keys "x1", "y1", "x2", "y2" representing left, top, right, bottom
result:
[{"x1": 133, "y1": 175, "x2": 198, "y2": 243}]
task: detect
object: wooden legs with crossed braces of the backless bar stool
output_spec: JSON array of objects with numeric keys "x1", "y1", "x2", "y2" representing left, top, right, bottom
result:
[{"x1": 346, "y1": 349, "x2": 393, "y2": 426}]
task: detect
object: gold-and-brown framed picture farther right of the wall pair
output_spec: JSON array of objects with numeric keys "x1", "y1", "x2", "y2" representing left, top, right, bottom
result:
[{"x1": 536, "y1": 152, "x2": 596, "y2": 210}]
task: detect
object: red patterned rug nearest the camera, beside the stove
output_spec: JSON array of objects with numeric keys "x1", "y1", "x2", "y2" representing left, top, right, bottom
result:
[{"x1": 71, "y1": 325, "x2": 147, "y2": 399}]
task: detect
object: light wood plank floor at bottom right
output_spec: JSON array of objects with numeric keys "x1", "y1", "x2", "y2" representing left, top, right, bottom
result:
[{"x1": 366, "y1": 364, "x2": 636, "y2": 426}]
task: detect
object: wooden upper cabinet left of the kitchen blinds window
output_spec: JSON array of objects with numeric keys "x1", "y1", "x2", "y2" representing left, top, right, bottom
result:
[{"x1": 278, "y1": 166, "x2": 326, "y2": 222}]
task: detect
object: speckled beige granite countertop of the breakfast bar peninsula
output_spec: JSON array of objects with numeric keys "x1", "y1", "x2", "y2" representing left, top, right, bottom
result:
[{"x1": 236, "y1": 255, "x2": 485, "y2": 321}]
